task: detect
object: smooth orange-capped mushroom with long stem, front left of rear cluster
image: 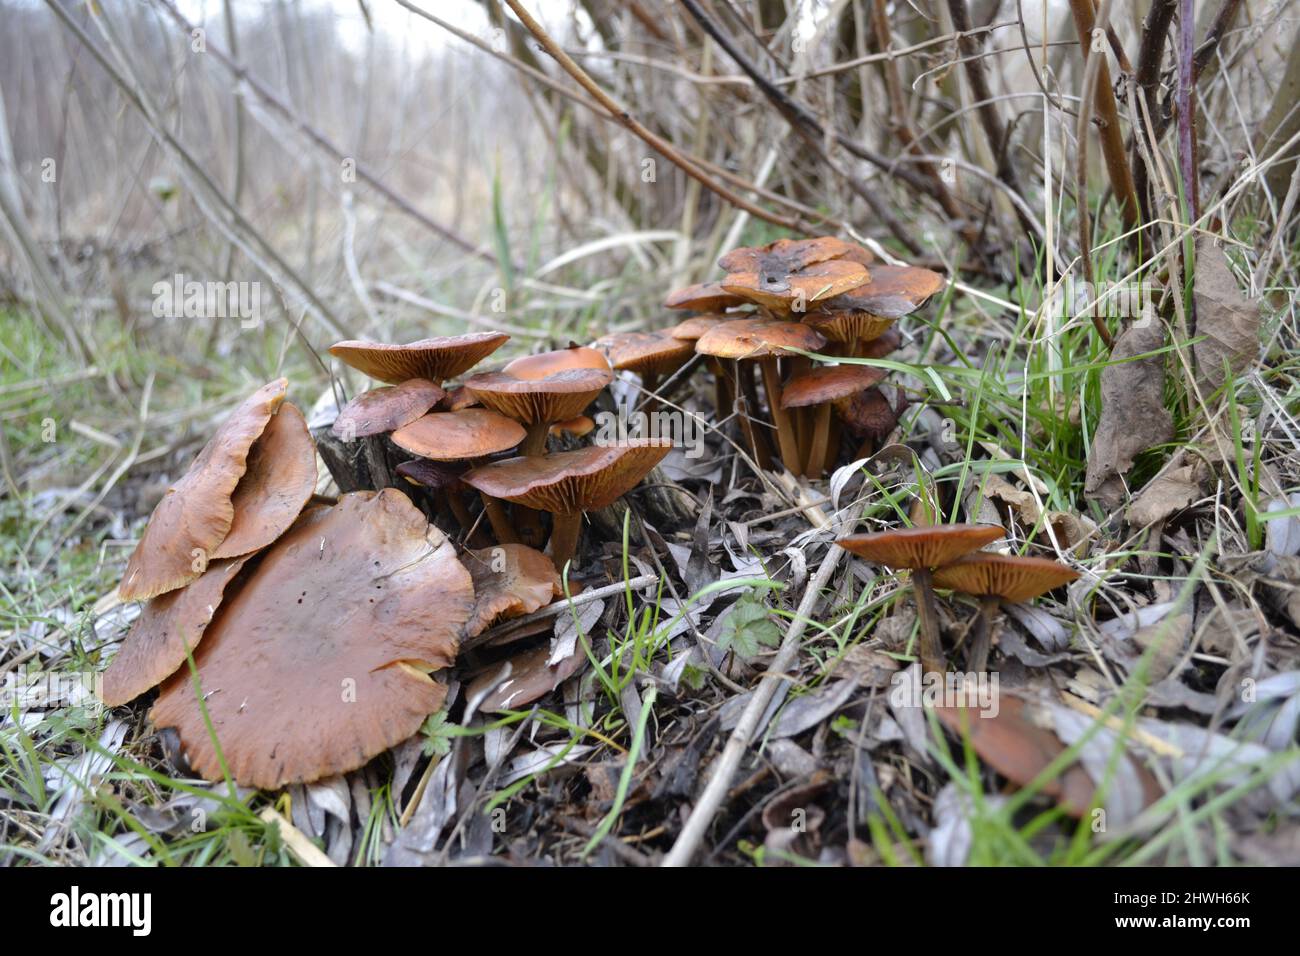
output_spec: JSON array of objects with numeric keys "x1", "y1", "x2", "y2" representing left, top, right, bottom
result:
[{"x1": 696, "y1": 319, "x2": 826, "y2": 472}]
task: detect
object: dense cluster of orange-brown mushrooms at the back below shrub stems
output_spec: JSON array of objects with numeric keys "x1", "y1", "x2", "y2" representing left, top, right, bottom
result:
[{"x1": 660, "y1": 237, "x2": 944, "y2": 479}]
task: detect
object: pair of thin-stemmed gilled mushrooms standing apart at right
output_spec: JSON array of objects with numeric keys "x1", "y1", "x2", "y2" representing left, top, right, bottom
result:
[{"x1": 836, "y1": 524, "x2": 1079, "y2": 674}]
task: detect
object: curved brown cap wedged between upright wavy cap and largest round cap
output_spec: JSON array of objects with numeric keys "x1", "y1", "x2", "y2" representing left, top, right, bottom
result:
[{"x1": 209, "y1": 402, "x2": 316, "y2": 559}]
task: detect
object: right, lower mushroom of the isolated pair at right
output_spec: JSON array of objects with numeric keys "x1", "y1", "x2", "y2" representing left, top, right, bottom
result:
[{"x1": 933, "y1": 554, "x2": 1079, "y2": 671}]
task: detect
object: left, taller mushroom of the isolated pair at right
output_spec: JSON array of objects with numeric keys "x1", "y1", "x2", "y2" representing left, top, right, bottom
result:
[{"x1": 836, "y1": 524, "x2": 1005, "y2": 674}]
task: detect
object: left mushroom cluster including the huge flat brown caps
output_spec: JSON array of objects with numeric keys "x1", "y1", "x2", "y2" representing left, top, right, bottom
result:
[{"x1": 101, "y1": 325, "x2": 670, "y2": 788}]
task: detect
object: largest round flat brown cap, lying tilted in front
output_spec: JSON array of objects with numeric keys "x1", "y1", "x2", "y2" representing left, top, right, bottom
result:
[{"x1": 150, "y1": 488, "x2": 473, "y2": 790}]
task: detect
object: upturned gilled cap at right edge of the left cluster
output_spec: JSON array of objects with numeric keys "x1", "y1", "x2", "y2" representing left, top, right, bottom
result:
[{"x1": 464, "y1": 440, "x2": 672, "y2": 515}]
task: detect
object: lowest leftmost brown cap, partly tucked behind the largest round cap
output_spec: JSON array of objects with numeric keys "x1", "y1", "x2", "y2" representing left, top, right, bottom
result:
[{"x1": 101, "y1": 558, "x2": 246, "y2": 708}]
